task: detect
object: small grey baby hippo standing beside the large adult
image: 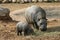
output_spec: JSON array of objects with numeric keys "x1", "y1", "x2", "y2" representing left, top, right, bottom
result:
[{"x1": 16, "y1": 22, "x2": 33, "y2": 35}]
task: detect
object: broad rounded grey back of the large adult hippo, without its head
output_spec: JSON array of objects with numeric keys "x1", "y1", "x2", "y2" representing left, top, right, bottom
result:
[{"x1": 25, "y1": 5, "x2": 46, "y2": 23}]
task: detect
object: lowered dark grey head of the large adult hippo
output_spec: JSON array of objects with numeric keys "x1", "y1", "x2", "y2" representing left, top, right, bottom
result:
[{"x1": 37, "y1": 19, "x2": 47, "y2": 31}]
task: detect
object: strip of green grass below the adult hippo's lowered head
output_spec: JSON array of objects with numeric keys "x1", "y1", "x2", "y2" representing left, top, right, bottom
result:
[{"x1": 33, "y1": 31, "x2": 60, "y2": 36}]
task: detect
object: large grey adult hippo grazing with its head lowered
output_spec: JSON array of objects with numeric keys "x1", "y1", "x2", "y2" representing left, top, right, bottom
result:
[{"x1": 25, "y1": 5, "x2": 47, "y2": 31}]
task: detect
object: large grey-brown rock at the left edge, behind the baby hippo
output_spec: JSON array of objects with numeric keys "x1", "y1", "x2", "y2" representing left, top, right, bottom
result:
[{"x1": 0, "y1": 7, "x2": 11, "y2": 20}]
